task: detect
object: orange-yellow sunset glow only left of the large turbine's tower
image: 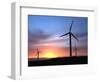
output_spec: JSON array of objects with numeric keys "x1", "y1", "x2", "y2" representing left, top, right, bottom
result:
[{"x1": 28, "y1": 46, "x2": 68, "y2": 58}]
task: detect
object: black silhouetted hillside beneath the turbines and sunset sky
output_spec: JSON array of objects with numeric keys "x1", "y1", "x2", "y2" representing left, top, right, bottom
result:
[{"x1": 28, "y1": 56, "x2": 88, "y2": 66}]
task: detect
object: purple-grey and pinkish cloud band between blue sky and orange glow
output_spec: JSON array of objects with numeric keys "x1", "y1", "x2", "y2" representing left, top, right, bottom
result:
[{"x1": 28, "y1": 29, "x2": 87, "y2": 49}]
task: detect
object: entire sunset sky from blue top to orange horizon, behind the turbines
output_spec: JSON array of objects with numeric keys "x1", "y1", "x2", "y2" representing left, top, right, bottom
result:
[{"x1": 28, "y1": 15, "x2": 88, "y2": 58}]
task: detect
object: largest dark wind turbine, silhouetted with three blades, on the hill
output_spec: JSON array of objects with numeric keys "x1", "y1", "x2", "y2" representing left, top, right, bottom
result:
[{"x1": 60, "y1": 21, "x2": 78, "y2": 56}]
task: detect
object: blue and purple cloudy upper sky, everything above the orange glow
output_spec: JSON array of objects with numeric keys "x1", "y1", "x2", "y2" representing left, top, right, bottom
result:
[{"x1": 28, "y1": 15, "x2": 88, "y2": 48}]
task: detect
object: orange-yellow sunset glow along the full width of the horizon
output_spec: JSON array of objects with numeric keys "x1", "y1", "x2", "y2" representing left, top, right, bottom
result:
[{"x1": 28, "y1": 46, "x2": 87, "y2": 59}]
